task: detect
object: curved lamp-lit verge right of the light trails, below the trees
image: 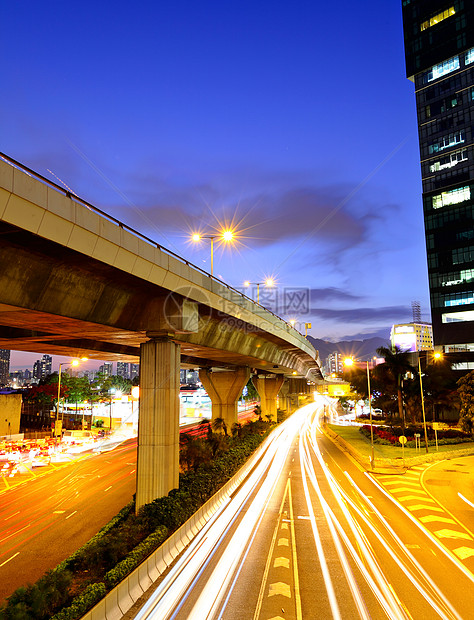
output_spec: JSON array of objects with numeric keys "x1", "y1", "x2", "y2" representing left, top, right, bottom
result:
[{"x1": 323, "y1": 424, "x2": 474, "y2": 474}]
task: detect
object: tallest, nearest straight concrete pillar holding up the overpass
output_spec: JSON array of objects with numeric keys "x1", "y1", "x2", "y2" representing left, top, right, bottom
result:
[{"x1": 136, "y1": 336, "x2": 180, "y2": 510}]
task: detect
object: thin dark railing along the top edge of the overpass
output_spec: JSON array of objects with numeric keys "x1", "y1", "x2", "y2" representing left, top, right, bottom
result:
[{"x1": 0, "y1": 152, "x2": 308, "y2": 348}]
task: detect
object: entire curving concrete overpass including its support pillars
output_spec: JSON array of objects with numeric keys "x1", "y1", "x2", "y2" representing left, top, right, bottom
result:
[{"x1": 0, "y1": 154, "x2": 321, "y2": 506}]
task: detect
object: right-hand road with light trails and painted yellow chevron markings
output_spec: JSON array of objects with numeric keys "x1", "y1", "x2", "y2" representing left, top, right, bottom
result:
[{"x1": 131, "y1": 399, "x2": 474, "y2": 620}]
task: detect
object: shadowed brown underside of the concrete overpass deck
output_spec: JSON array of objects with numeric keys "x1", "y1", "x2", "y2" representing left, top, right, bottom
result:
[{"x1": 0, "y1": 222, "x2": 319, "y2": 376}]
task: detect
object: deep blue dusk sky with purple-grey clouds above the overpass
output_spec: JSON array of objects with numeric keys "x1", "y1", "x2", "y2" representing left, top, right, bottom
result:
[{"x1": 0, "y1": 0, "x2": 430, "y2": 368}]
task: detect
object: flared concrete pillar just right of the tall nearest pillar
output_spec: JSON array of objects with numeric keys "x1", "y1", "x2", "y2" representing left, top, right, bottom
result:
[{"x1": 199, "y1": 368, "x2": 250, "y2": 431}]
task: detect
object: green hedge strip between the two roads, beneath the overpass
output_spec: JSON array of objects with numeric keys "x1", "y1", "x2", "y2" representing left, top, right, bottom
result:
[{"x1": 0, "y1": 422, "x2": 272, "y2": 620}]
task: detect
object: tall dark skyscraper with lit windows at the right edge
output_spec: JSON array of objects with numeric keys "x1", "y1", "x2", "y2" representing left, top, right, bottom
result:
[{"x1": 402, "y1": 0, "x2": 474, "y2": 369}]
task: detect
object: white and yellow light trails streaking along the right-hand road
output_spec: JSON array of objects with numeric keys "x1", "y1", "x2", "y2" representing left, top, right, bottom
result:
[{"x1": 131, "y1": 400, "x2": 466, "y2": 620}]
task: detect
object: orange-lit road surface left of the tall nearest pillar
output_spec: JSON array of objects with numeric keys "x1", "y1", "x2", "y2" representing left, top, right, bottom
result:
[{"x1": 0, "y1": 439, "x2": 137, "y2": 600}]
